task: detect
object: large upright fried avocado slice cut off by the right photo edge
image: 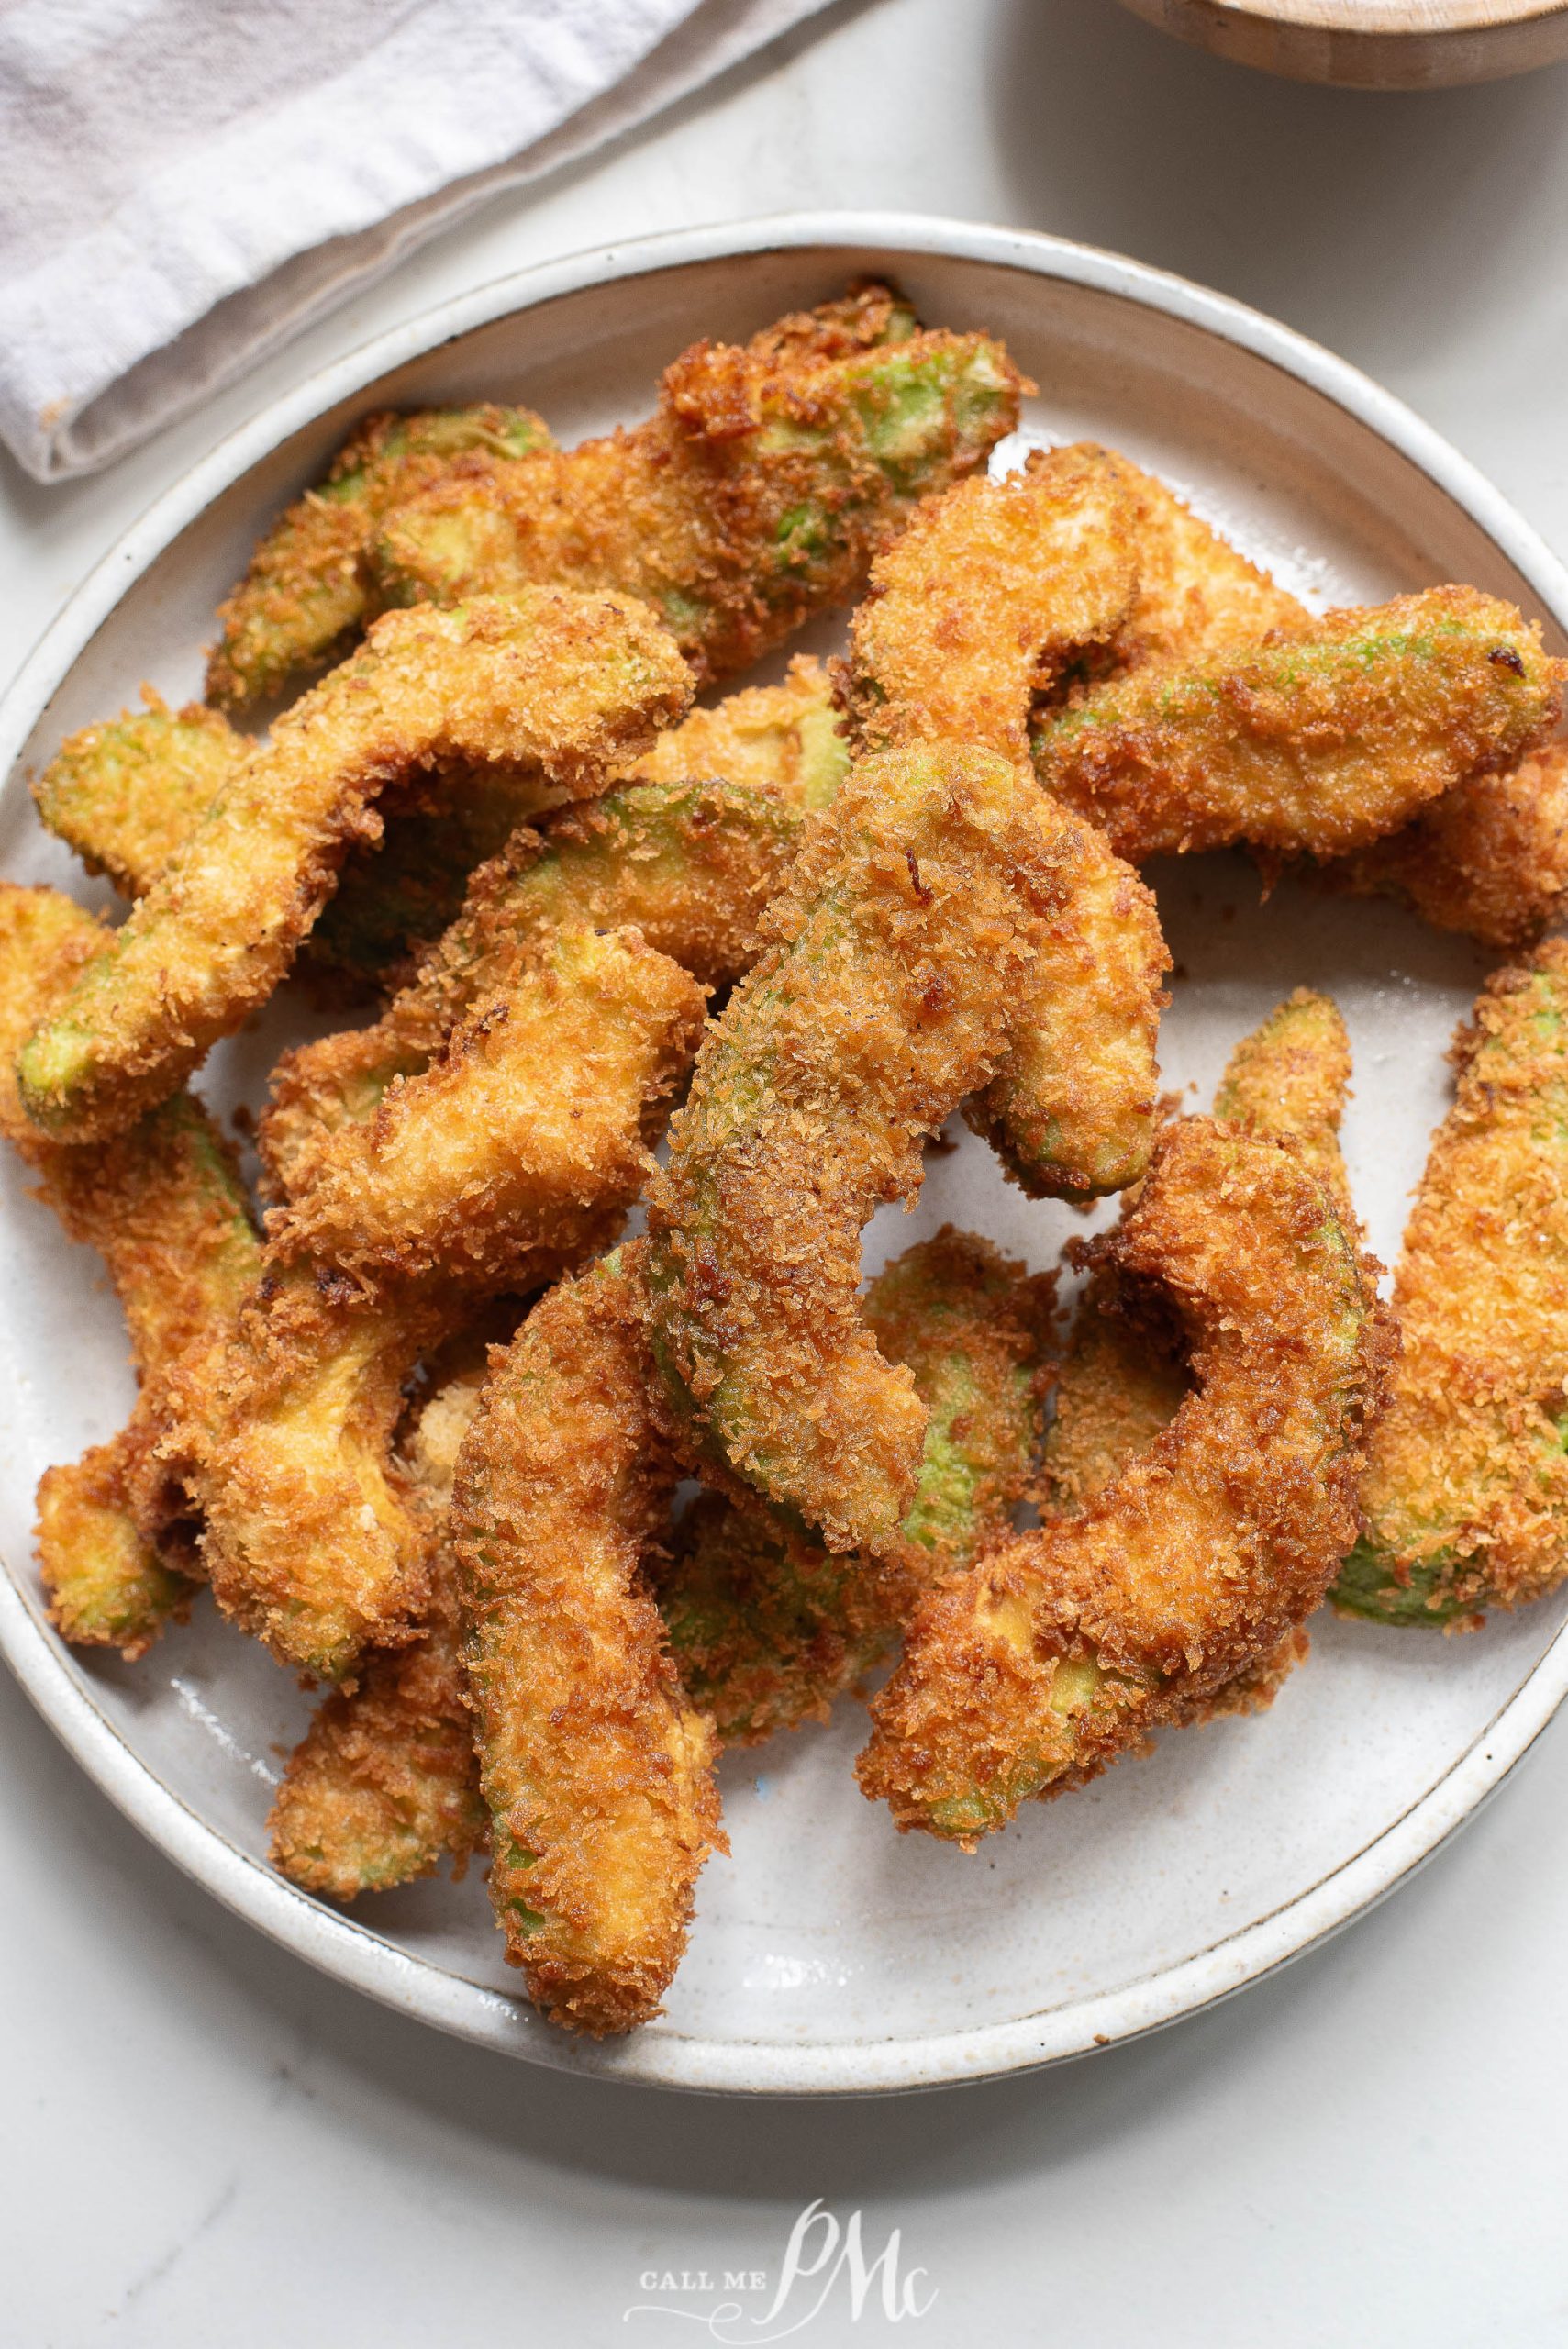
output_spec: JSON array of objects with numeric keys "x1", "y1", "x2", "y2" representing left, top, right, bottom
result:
[{"x1": 1333, "y1": 940, "x2": 1568, "y2": 1628}]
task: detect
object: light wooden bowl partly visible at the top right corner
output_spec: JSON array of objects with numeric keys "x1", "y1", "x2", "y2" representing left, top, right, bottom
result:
[{"x1": 1122, "y1": 0, "x2": 1568, "y2": 89}]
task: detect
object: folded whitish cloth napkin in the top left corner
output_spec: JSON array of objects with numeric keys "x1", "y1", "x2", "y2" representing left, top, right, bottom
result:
[{"x1": 0, "y1": 0, "x2": 827, "y2": 482}]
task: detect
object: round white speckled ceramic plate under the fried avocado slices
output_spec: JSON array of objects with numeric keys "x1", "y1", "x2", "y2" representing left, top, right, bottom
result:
[{"x1": 0, "y1": 217, "x2": 1568, "y2": 2093}]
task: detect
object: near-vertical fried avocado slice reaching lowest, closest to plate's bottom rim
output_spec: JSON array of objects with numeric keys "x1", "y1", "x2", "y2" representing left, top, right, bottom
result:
[{"x1": 450, "y1": 1250, "x2": 726, "y2": 2037}]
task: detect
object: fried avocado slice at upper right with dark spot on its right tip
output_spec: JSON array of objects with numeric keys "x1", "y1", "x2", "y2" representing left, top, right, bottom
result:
[{"x1": 1035, "y1": 587, "x2": 1563, "y2": 864}]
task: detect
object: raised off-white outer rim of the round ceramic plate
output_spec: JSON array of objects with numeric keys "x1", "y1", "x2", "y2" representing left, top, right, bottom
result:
[{"x1": 0, "y1": 211, "x2": 1568, "y2": 2096}]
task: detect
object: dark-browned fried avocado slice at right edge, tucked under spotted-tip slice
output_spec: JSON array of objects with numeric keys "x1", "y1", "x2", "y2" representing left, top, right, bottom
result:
[{"x1": 1324, "y1": 742, "x2": 1568, "y2": 952}]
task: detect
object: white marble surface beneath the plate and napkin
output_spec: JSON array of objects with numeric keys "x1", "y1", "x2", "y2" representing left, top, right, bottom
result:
[{"x1": 0, "y1": 0, "x2": 1568, "y2": 2349}]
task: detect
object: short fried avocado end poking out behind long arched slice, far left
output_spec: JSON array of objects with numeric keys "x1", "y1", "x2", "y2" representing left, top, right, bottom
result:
[{"x1": 33, "y1": 686, "x2": 251, "y2": 897}]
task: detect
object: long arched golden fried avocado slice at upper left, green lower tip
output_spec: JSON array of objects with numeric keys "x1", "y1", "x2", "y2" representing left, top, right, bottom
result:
[{"x1": 18, "y1": 590, "x2": 690, "y2": 1141}]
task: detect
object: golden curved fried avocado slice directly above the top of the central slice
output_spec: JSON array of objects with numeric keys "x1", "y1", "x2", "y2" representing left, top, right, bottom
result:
[{"x1": 845, "y1": 441, "x2": 1139, "y2": 761}]
